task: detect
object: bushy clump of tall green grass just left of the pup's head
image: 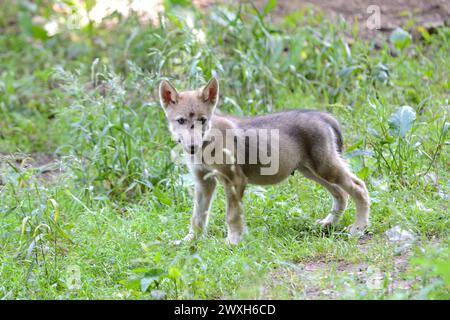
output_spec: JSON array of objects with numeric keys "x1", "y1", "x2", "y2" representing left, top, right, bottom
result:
[{"x1": 52, "y1": 64, "x2": 172, "y2": 199}]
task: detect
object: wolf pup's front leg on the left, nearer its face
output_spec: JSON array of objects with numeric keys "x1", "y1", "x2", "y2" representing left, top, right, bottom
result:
[{"x1": 184, "y1": 170, "x2": 216, "y2": 241}]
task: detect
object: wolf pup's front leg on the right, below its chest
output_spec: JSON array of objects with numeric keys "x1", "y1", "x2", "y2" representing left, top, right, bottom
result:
[{"x1": 224, "y1": 171, "x2": 246, "y2": 245}]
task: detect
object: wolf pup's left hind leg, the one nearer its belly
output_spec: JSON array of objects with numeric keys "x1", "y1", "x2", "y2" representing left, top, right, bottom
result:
[{"x1": 299, "y1": 168, "x2": 348, "y2": 227}]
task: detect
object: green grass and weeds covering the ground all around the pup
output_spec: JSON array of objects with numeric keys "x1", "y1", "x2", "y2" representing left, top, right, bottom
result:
[{"x1": 0, "y1": 3, "x2": 450, "y2": 299}]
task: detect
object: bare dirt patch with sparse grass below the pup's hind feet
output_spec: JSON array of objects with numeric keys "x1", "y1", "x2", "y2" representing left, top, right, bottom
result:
[{"x1": 260, "y1": 242, "x2": 417, "y2": 300}]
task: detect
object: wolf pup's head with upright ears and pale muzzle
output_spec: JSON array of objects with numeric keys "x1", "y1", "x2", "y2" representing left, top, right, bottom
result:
[{"x1": 159, "y1": 78, "x2": 219, "y2": 154}]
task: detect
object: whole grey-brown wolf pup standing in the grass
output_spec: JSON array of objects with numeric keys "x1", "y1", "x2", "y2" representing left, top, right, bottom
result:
[{"x1": 159, "y1": 78, "x2": 370, "y2": 245}]
